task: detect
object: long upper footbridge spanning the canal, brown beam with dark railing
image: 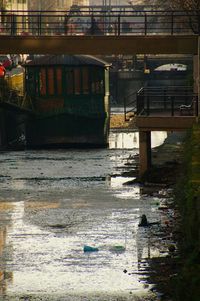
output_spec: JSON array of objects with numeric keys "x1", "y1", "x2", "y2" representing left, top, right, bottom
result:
[{"x1": 0, "y1": 6, "x2": 199, "y2": 55}]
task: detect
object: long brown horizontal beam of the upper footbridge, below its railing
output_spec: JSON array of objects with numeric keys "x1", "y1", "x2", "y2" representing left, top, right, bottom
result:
[{"x1": 0, "y1": 35, "x2": 198, "y2": 55}]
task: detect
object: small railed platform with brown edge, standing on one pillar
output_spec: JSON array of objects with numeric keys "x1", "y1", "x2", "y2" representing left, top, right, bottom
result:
[{"x1": 125, "y1": 86, "x2": 199, "y2": 175}]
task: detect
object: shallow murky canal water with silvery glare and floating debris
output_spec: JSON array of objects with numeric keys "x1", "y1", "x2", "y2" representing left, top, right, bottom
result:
[{"x1": 0, "y1": 133, "x2": 169, "y2": 301}]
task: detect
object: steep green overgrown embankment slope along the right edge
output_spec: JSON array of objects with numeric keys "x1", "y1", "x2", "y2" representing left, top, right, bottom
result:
[{"x1": 175, "y1": 124, "x2": 200, "y2": 301}]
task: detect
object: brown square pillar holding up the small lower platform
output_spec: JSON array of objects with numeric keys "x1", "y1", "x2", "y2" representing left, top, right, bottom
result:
[{"x1": 139, "y1": 131, "x2": 151, "y2": 176}]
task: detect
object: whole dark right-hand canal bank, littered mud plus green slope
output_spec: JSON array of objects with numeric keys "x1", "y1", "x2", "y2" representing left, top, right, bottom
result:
[{"x1": 133, "y1": 124, "x2": 200, "y2": 301}]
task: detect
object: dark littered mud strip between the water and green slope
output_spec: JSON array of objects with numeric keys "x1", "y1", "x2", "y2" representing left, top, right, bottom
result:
[{"x1": 125, "y1": 133, "x2": 186, "y2": 301}]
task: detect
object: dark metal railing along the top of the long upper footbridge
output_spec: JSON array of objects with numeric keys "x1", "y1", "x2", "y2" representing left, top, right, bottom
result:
[{"x1": 0, "y1": 8, "x2": 199, "y2": 36}]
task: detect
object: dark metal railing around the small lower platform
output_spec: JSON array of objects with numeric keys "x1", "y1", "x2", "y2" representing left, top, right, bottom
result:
[{"x1": 137, "y1": 86, "x2": 198, "y2": 116}]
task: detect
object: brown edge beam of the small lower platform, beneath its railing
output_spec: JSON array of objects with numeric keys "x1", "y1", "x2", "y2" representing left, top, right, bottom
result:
[{"x1": 136, "y1": 116, "x2": 196, "y2": 131}]
